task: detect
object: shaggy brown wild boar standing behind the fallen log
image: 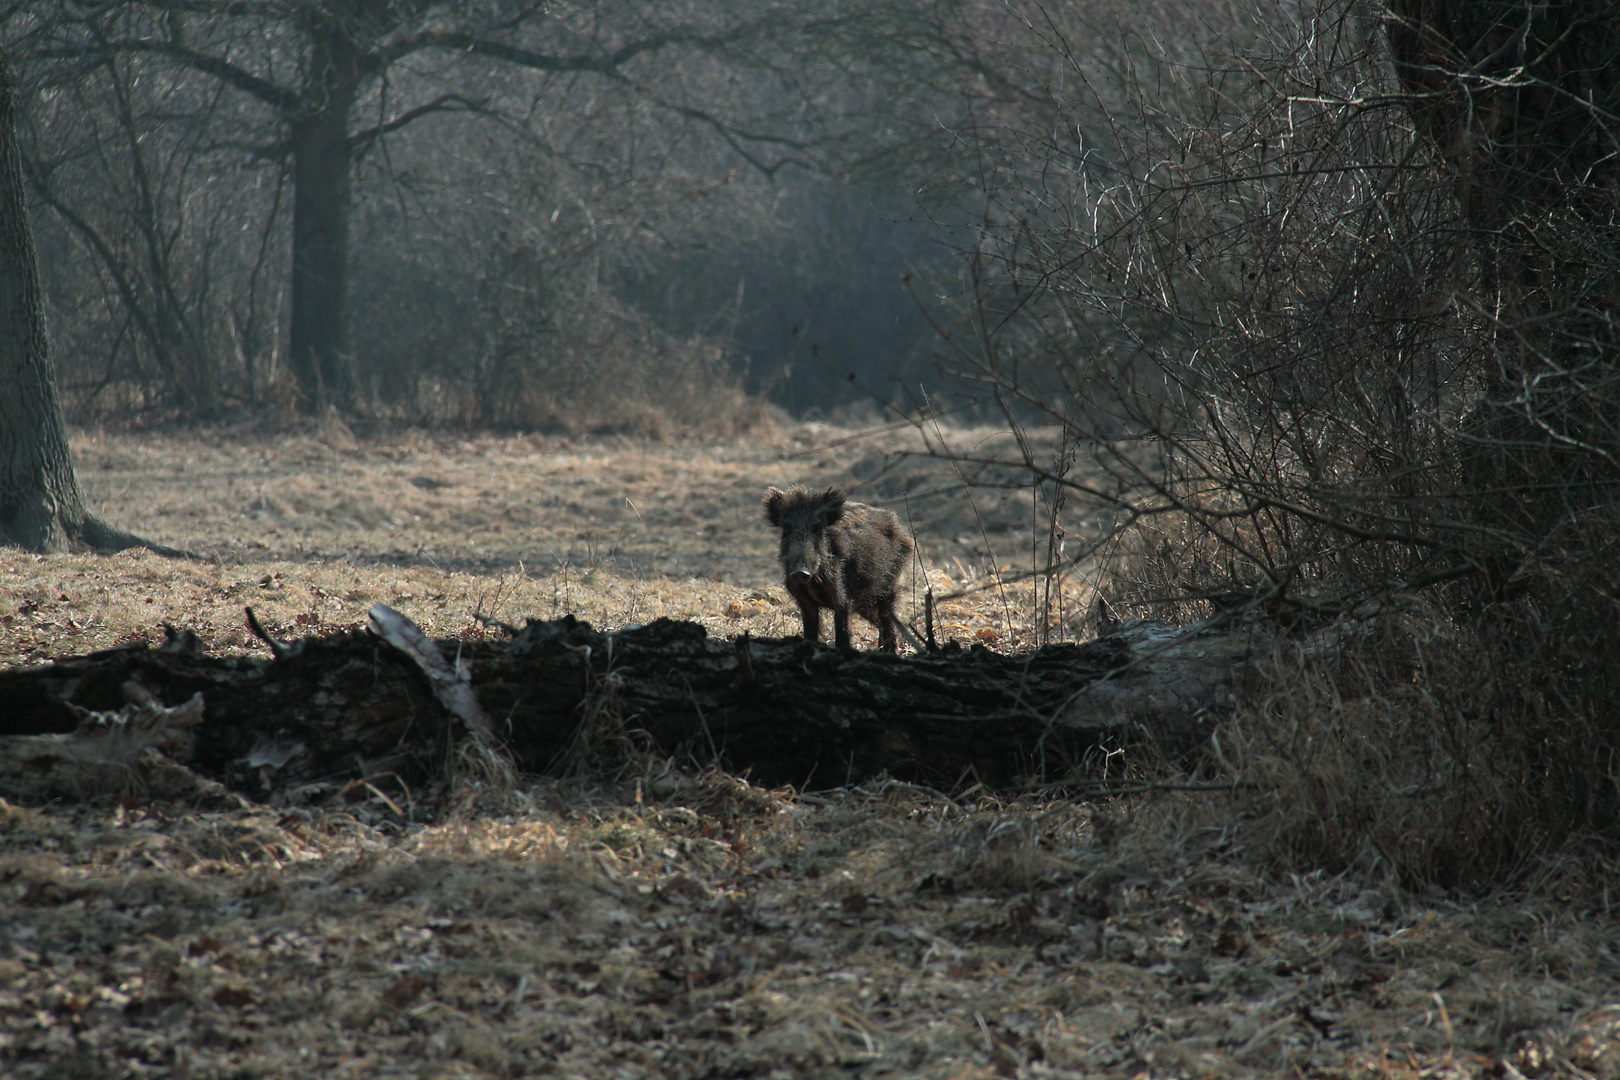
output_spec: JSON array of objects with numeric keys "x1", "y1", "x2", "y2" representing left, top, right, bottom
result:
[{"x1": 765, "y1": 487, "x2": 917, "y2": 653}]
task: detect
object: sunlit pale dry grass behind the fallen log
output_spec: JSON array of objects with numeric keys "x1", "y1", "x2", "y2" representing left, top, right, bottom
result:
[{"x1": 0, "y1": 424, "x2": 1100, "y2": 664}]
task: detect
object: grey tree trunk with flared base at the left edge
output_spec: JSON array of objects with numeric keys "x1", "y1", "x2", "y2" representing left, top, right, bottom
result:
[{"x1": 0, "y1": 52, "x2": 167, "y2": 552}]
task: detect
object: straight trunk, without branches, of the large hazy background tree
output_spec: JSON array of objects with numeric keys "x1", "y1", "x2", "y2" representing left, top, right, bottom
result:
[{"x1": 290, "y1": 15, "x2": 360, "y2": 411}]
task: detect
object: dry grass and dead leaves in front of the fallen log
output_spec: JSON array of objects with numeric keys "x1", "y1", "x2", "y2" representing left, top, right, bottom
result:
[{"x1": 0, "y1": 786, "x2": 1620, "y2": 1080}]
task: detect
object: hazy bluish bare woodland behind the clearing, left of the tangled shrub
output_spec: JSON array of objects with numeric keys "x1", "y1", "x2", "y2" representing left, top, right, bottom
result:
[{"x1": 3, "y1": 0, "x2": 1023, "y2": 427}]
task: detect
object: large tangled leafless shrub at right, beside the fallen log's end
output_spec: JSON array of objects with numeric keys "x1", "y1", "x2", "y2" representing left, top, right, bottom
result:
[{"x1": 949, "y1": 2, "x2": 1620, "y2": 884}]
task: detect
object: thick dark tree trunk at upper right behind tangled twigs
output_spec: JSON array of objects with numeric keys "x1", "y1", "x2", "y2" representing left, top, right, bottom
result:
[{"x1": 1387, "y1": 0, "x2": 1620, "y2": 538}]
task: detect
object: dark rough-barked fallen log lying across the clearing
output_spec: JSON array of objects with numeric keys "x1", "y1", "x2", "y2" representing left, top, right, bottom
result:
[{"x1": 0, "y1": 617, "x2": 1252, "y2": 800}]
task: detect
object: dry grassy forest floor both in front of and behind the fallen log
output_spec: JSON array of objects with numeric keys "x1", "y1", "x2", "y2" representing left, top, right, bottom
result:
[{"x1": 0, "y1": 426, "x2": 1620, "y2": 1078}]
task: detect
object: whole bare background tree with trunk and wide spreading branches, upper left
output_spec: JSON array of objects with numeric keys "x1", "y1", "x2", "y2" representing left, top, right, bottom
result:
[{"x1": 12, "y1": 0, "x2": 946, "y2": 408}]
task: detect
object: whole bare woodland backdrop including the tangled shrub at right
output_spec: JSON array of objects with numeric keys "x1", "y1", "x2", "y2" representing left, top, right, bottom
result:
[{"x1": 0, "y1": 0, "x2": 1620, "y2": 904}]
